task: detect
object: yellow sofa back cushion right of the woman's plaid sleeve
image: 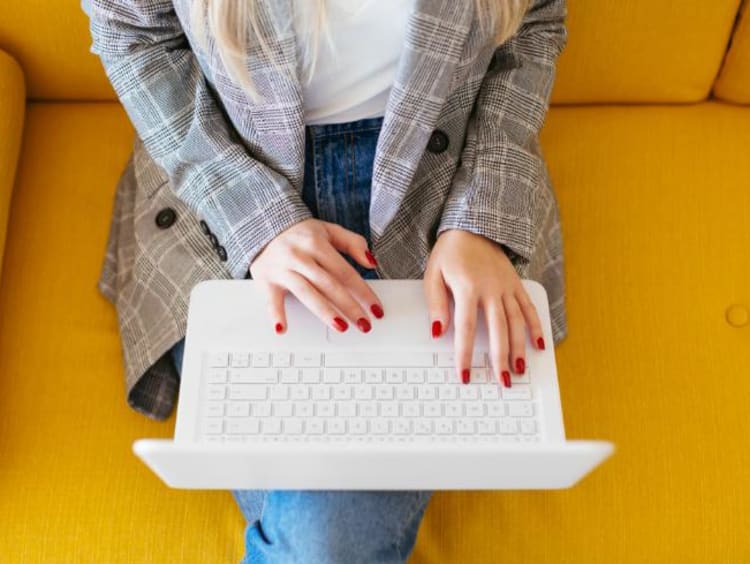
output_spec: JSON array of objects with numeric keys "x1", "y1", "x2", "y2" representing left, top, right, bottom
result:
[{"x1": 552, "y1": 0, "x2": 739, "y2": 104}]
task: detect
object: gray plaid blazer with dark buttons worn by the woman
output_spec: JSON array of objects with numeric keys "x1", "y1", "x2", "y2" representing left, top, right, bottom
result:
[{"x1": 82, "y1": 0, "x2": 567, "y2": 418}]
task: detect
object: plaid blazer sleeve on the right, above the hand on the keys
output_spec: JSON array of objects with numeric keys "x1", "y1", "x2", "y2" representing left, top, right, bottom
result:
[{"x1": 436, "y1": 0, "x2": 567, "y2": 261}]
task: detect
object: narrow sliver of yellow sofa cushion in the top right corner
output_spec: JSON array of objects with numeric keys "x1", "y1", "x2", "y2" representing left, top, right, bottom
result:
[{"x1": 714, "y1": 2, "x2": 750, "y2": 104}]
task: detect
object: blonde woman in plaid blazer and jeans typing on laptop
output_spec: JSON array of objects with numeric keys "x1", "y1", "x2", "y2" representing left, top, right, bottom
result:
[{"x1": 84, "y1": 0, "x2": 566, "y2": 562}]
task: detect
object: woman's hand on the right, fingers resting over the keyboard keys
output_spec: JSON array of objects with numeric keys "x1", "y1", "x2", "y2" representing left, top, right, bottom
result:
[{"x1": 424, "y1": 229, "x2": 544, "y2": 387}]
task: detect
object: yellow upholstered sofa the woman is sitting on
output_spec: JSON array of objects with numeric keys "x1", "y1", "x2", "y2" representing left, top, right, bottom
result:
[{"x1": 0, "y1": 0, "x2": 750, "y2": 564}]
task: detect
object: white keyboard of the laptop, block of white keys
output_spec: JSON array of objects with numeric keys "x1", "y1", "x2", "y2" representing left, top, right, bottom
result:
[{"x1": 198, "y1": 351, "x2": 540, "y2": 442}]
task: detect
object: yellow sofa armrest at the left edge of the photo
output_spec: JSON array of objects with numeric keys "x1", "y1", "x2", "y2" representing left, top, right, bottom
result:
[{"x1": 0, "y1": 50, "x2": 26, "y2": 280}]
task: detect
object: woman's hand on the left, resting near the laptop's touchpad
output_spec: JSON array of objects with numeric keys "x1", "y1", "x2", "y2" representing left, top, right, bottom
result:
[{"x1": 249, "y1": 218, "x2": 383, "y2": 333}]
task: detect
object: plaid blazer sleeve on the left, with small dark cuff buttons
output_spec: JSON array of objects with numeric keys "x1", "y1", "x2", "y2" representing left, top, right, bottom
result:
[{"x1": 82, "y1": 0, "x2": 312, "y2": 278}]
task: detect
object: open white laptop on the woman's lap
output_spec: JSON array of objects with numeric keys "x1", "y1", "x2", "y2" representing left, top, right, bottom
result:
[{"x1": 133, "y1": 280, "x2": 613, "y2": 490}]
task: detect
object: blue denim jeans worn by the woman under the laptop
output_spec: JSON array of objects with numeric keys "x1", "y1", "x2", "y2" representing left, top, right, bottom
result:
[{"x1": 167, "y1": 118, "x2": 432, "y2": 564}]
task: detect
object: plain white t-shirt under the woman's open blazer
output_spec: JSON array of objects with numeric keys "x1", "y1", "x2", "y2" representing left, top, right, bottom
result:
[{"x1": 294, "y1": 0, "x2": 414, "y2": 125}]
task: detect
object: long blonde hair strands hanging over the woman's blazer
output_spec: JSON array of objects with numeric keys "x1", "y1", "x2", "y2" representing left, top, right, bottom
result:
[{"x1": 191, "y1": 0, "x2": 531, "y2": 100}]
